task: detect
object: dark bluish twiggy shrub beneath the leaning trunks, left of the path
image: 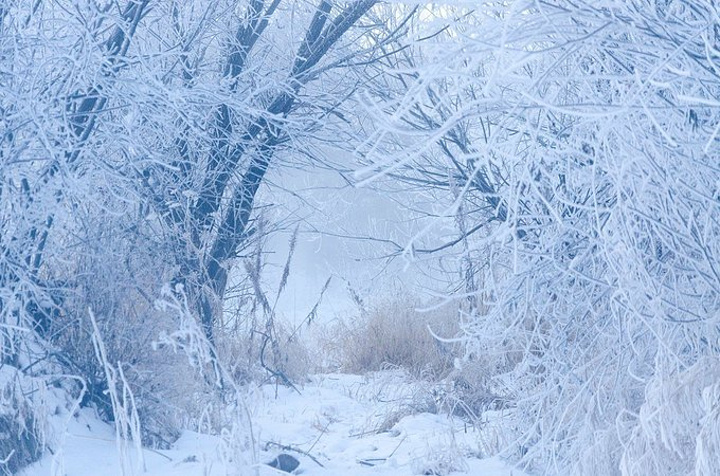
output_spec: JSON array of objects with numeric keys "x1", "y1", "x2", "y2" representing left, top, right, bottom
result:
[{"x1": 50, "y1": 272, "x2": 200, "y2": 448}]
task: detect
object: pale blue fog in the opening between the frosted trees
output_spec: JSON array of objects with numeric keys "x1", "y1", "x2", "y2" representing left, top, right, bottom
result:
[{"x1": 263, "y1": 162, "x2": 452, "y2": 323}]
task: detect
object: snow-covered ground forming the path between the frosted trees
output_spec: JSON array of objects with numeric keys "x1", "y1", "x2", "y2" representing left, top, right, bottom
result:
[{"x1": 21, "y1": 372, "x2": 524, "y2": 476}]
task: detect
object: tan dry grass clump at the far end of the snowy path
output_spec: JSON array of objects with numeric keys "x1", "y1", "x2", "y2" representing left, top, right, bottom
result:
[{"x1": 320, "y1": 293, "x2": 512, "y2": 426}]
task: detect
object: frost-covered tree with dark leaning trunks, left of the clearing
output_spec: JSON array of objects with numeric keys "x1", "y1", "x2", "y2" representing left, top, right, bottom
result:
[{"x1": 2, "y1": 1, "x2": 400, "y2": 362}]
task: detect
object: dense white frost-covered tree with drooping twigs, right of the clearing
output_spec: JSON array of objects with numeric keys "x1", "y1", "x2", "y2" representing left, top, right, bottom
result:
[{"x1": 362, "y1": 0, "x2": 720, "y2": 475}]
